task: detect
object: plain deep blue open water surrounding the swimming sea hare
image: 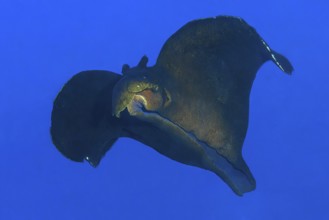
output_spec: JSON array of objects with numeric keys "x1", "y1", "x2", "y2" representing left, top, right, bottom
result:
[{"x1": 0, "y1": 0, "x2": 329, "y2": 220}]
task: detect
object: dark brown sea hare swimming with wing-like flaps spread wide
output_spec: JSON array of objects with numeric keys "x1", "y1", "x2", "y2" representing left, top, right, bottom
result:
[{"x1": 51, "y1": 16, "x2": 293, "y2": 195}]
